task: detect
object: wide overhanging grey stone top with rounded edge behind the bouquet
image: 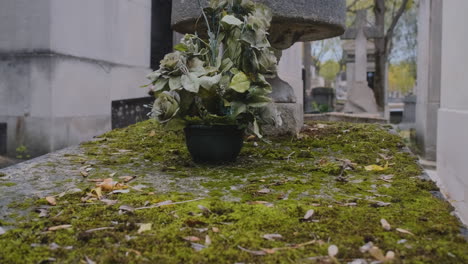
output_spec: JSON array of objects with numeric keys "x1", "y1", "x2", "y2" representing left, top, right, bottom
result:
[{"x1": 172, "y1": 0, "x2": 346, "y2": 49}]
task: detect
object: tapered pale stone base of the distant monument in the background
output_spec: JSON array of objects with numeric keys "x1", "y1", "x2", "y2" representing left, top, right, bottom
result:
[{"x1": 344, "y1": 81, "x2": 379, "y2": 114}]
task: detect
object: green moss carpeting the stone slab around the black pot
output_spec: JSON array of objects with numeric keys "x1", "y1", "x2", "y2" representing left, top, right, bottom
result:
[{"x1": 0, "y1": 121, "x2": 468, "y2": 263}]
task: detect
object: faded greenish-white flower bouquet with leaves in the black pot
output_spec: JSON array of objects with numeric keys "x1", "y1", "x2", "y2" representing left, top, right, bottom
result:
[{"x1": 148, "y1": 0, "x2": 277, "y2": 136}]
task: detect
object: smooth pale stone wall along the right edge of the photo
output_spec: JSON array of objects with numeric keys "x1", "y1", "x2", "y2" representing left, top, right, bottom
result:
[{"x1": 437, "y1": 0, "x2": 468, "y2": 223}]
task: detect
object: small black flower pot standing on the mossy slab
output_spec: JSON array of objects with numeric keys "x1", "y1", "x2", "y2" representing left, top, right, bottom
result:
[{"x1": 185, "y1": 125, "x2": 244, "y2": 163}]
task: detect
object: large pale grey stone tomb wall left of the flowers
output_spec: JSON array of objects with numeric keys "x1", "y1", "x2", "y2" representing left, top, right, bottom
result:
[{"x1": 0, "y1": 0, "x2": 151, "y2": 156}]
